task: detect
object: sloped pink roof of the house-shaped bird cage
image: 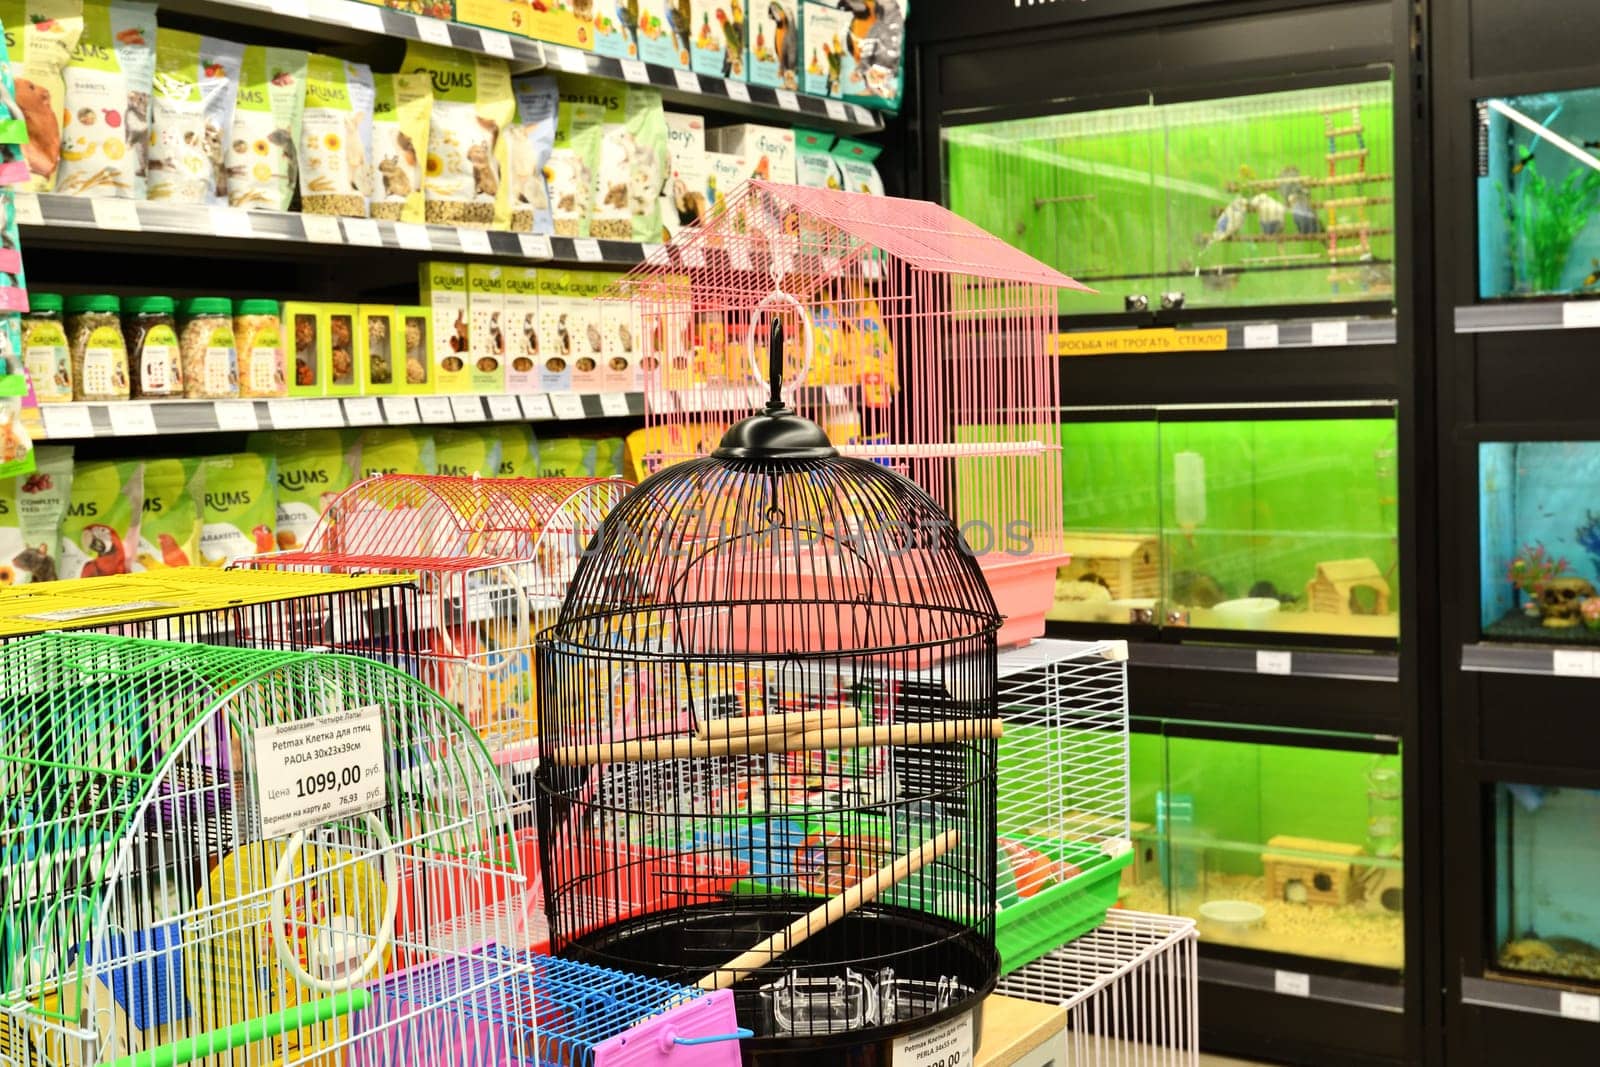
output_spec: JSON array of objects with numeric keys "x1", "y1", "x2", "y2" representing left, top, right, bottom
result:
[{"x1": 637, "y1": 179, "x2": 1094, "y2": 293}]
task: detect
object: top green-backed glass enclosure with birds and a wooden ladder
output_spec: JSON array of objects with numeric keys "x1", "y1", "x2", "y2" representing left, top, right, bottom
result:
[{"x1": 941, "y1": 75, "x2": 1395, "y2": 315}]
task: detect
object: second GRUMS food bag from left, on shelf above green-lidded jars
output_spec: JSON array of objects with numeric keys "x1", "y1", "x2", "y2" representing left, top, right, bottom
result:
[{"x1": 56, "y1": 0, "x2": 155, "y2": 198}]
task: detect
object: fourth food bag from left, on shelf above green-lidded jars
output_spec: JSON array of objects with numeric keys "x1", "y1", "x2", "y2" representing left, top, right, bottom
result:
[{"x1": 226, "y1": 45, "x2": 307, "y2": 211}]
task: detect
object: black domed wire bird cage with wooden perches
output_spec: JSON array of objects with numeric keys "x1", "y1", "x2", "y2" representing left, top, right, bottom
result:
[{"x1": 538, "y1": 310, "x2": 1002, "y2": 1064}]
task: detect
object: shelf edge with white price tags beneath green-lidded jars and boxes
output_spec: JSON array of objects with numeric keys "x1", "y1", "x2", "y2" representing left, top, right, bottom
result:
[{"x1": 40, "y1": 394, "x2": 645, "y2": 442}]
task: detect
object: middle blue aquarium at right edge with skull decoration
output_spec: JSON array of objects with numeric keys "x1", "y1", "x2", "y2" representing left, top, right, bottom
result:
[{"x1": 1478, "y1": 442, "x2": 1600, "y2": 645}]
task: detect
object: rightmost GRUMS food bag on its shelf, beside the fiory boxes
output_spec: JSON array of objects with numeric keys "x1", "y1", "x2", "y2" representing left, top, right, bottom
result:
[{"x1": 589, "y1": 85, "x2": 667, "y2": 242}]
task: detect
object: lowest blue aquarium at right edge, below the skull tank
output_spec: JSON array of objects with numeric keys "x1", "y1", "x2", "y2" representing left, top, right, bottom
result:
[{"x1": 1494, "y1": 784, "x2": 1600, "y2": 982}]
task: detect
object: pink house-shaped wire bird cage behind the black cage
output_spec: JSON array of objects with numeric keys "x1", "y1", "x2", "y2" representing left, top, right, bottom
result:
[{"x1": 608, "y1": 181, "x2": 1088, "y2": 645}]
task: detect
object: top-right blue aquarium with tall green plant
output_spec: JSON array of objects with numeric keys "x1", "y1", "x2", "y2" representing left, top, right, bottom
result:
[{"x1": 1478, "y1": 88, "x2": 1600, "y2": 301}]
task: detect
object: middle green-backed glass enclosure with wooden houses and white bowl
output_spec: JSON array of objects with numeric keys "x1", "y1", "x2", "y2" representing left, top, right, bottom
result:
[{"x1": 1050, "y1": 405, "x2": 1400, "y2": 645}]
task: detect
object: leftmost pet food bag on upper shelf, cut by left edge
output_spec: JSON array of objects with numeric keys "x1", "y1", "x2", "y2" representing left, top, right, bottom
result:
[{"x1": 0, "y1": 0, "x2": 83, "y2": 192}]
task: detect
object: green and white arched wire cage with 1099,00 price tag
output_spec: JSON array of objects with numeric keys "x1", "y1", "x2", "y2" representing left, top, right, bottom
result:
[{"x1": 0, "y1": 633, "x2": 526, "y2": 1067}]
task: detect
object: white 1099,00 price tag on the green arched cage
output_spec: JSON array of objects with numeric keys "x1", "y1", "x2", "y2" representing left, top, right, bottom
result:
[{"x1": 256, "y1": 704, "x2": 389, "y2": 840}]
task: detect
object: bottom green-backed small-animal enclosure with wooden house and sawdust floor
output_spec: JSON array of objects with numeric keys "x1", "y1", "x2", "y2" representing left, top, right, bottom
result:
[{"x1": 1122, "y1": 720, "x2": 1405, "y2": 969}]
